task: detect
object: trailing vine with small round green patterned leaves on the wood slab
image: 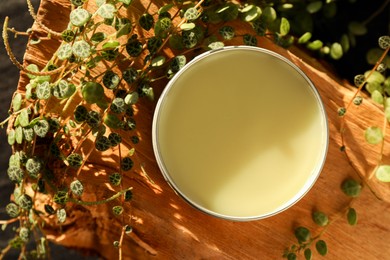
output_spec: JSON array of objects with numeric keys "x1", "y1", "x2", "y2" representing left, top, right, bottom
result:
[{"x1": 0, "y1": 0, "x2": 390, "y2": 259}]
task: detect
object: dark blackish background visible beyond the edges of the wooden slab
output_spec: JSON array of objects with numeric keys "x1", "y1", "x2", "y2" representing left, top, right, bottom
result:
[{"x1": 0, "y1": 0, "x2": 390, "y2": 260}]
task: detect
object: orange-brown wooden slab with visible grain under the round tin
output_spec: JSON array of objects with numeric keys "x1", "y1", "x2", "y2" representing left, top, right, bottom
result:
[{"x1": 12, "y1": 0, "x2": 390, "y2": 259}]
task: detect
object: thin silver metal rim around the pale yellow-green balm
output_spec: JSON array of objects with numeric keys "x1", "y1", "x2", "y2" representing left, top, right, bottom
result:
[{"x1": 152, "y1": 46, "x2": 329, "y2": 221}]
